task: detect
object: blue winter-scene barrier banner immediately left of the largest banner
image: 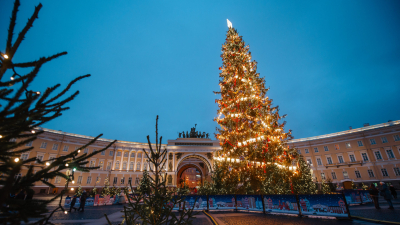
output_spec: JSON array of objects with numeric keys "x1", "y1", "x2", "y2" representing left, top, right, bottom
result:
[{"x1": 263, "y1": 195, "x2": 299, "y2": 214}]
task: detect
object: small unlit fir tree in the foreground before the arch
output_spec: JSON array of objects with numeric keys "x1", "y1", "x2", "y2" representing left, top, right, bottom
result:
[{"x1": 107, "y1": 116, "x2": 194, "y2": 225}]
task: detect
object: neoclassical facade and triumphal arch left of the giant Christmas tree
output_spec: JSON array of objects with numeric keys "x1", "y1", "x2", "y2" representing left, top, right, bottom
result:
[{"x1": 20, "y1": 128, "x2": 219, "y2": 193}]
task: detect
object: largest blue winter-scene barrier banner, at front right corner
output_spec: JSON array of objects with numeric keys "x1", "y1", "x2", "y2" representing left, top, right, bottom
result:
[{"x1": 298, "y1": 194, "x2": 349, "y2": 217}]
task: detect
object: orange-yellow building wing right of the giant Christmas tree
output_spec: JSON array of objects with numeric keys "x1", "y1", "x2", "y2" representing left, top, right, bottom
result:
[{"x1": 290, "y1": 120, "x2": 400, "y2": 187}]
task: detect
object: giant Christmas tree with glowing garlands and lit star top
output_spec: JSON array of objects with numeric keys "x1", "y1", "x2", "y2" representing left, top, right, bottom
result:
[{"x1": 215, "y1": 21, "x2": 296, "y2": 194}]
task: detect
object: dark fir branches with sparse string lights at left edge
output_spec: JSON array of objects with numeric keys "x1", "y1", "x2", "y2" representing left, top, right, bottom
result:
[{"x1": 0, "y1": 0, "x2": 114, "y2": 224}]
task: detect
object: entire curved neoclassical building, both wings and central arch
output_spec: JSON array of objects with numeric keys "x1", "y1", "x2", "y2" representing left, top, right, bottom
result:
[{"x1": 13, "y1": 120, "x2": 400, "y2": 193}]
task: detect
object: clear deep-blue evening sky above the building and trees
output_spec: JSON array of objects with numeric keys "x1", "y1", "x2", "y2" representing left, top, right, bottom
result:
[{"x1": 0, "y1": 0, "x2": 400, "y2": 143}]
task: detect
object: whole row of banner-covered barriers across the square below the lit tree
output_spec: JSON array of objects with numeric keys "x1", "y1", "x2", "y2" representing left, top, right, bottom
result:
[{"x1": 65, "y1": 190, "x2": 372, "y2": 218}]
